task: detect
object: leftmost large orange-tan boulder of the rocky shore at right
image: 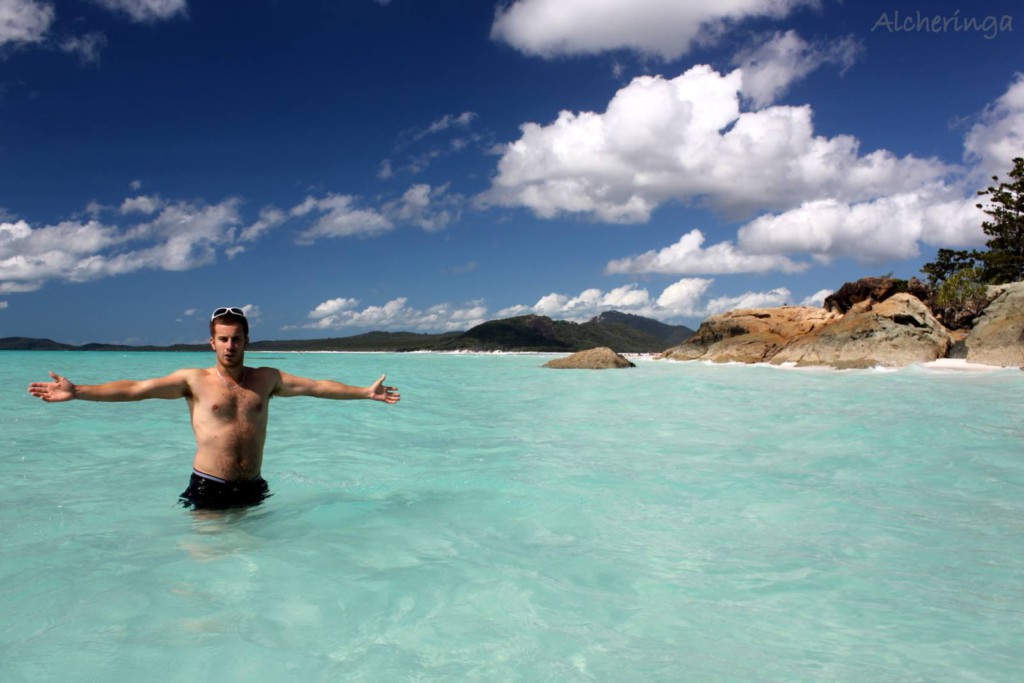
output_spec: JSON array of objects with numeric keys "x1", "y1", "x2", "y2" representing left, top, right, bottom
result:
[{"x1": 662, "y1": 306, "x2": 840, "y2": 362}]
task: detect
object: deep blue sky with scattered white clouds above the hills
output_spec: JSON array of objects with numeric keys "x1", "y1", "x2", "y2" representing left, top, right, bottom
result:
[{"x1": 0, "y1": 0, "x2": 1024, "y2": 344}]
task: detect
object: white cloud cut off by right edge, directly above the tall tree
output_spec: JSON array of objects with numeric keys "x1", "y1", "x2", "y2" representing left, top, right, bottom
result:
[{"x1": 964, "y1": 74, "x2": 1024, "y2": 182}]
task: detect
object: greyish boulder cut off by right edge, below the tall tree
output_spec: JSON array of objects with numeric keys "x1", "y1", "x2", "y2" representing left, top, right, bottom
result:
[{"x1": 965, "y1": 283, "x2": 1024, "y2": 368}]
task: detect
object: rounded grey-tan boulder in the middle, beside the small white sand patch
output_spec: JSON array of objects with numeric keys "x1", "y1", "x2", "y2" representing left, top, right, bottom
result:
[{"x1": 771, "y1": 294, "x2": 953, "y2": 368}]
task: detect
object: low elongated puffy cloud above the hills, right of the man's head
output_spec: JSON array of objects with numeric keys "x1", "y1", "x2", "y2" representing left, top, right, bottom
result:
[{"x1": 302, "y1": 297, "x2": 487, "y2": 332}]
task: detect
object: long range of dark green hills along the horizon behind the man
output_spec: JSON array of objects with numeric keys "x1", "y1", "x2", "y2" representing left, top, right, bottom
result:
[{"x1": 0, "y1": 311, "x2": 693, "y2": 353}]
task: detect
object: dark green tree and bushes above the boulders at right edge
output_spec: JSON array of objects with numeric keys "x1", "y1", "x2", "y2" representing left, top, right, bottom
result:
[{"x1": 921, "y1": 157, "x2": 1024, "y2": 328}]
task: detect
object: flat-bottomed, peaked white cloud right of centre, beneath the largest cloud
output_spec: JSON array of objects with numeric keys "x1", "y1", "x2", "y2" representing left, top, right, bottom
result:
[{"x1": 605, "y1": 229, "x2": 809, "y2": 274}]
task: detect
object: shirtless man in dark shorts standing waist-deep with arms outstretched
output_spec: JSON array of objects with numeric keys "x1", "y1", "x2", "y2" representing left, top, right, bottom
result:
[{"x1": 29, "y1": 307, "x2": 400, "y2": 509}]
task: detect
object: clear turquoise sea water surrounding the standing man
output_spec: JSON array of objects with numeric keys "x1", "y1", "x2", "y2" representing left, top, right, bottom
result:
[{"x1": 0, "y1": 352, "x2": 1024, "y2": 682}]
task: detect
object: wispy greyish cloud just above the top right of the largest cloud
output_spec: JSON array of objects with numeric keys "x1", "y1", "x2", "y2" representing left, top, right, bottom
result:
[{"x1": 734, "y1": 31, "x2": 862, "y2": 109}]
